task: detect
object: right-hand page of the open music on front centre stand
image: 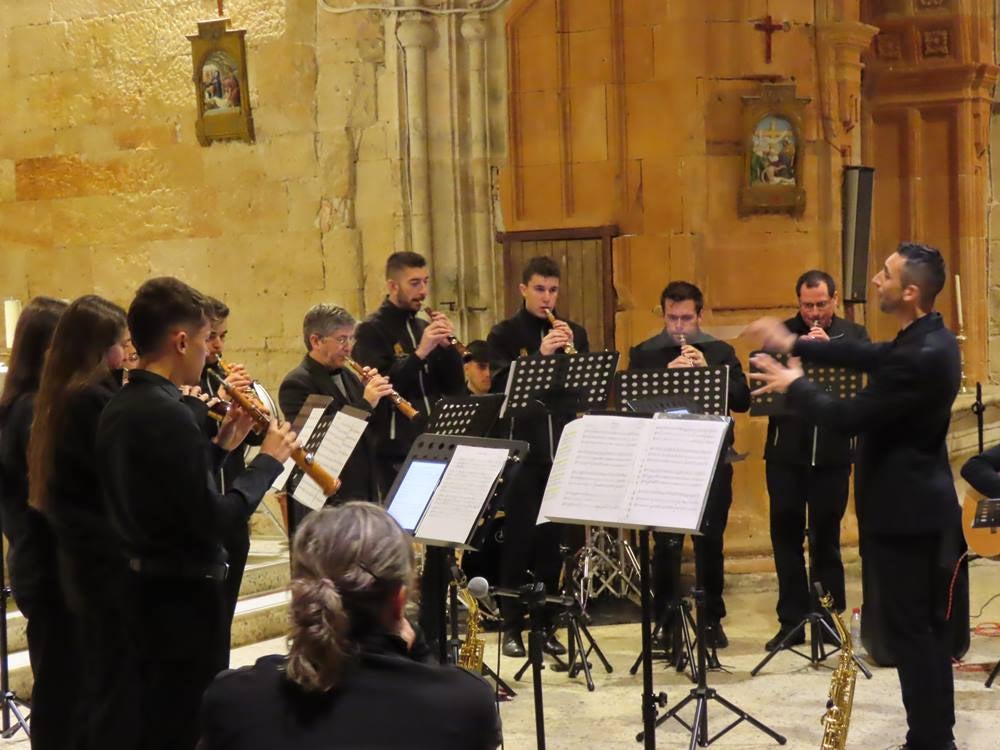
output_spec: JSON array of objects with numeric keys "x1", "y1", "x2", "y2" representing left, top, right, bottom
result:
[{"x1": 628, "y1": 418, "x2": 729, "y2": 531}]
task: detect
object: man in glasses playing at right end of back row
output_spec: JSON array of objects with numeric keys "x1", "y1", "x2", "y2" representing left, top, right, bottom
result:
[{"x1": 764, "y1": 270, "x2": 868, "y2": 651}]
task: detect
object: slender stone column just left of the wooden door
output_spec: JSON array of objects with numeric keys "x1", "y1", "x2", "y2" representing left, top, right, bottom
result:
[{"x1": 461, "y1": 13, "x2": 496, "y2": 337}]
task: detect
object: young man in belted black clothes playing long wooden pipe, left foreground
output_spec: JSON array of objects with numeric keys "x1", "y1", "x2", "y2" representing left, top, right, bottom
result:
[{"x1": 97, "y1": 277, "x2": 295, "y2": 750}]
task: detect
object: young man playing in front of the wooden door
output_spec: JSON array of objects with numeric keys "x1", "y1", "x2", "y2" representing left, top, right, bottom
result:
[{"x1": 487, "y1": 256, "x2": 589, "y2": 657}]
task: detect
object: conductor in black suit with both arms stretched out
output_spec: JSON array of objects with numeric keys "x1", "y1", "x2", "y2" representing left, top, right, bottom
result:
[{"x1": 750, "y1": 243, "x2": 964, "y2": 750}]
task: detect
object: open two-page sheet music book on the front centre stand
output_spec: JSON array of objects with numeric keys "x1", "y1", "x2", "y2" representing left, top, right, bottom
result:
[{"x1": 538, "y1": 414, "x2": 731, "y2": 533}]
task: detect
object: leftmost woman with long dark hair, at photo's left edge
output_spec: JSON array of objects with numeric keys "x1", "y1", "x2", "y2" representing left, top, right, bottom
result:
[{"x1": 0, "y1": 297, "x2": 69, "y2": 748}]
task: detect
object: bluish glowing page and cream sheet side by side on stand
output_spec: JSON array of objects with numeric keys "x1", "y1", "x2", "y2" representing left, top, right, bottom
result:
[{"x1": 388, "y1": 445, "x2": 510, "y2": 547}]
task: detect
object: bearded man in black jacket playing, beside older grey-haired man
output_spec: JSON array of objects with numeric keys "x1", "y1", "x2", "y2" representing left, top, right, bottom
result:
[{"x1": 354, "y1": 252, "x2": 465, "y2": 654}]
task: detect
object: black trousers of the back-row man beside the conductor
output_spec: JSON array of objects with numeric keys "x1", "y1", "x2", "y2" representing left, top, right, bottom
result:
[{"x1": 765, "y1": 461, "x2": 851, "y2": 627}]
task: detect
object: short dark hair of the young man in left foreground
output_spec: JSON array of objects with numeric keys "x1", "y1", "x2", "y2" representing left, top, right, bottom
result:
[{"x1": 128, "y1": 276, "x2": 212, "y2": 356}]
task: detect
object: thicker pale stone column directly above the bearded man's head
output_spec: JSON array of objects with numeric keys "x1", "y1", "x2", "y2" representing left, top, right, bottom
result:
[{"x1": 396, "y1": 5, "x2": 434, "y2": 262}]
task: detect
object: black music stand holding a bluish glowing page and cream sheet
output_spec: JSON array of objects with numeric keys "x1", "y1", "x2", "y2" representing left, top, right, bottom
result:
[{"x1": 386, "y1": 433, "x2": 529, "y2": 694}]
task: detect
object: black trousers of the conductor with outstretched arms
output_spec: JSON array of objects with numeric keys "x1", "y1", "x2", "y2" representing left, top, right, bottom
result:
[{"x1": 862, "y1": 532, "x2": 960, "y2": 750}]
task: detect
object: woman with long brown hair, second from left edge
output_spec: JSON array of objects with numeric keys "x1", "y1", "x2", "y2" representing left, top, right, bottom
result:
[{"x1": 28, "y1": 294, "x2": 129, "y2": 747}]
